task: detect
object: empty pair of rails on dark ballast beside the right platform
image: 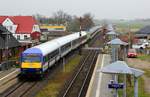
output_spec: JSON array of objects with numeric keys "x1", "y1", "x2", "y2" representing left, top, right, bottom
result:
[{"x1": 62, "y1": 50, "x2": 97, "y2": 97}]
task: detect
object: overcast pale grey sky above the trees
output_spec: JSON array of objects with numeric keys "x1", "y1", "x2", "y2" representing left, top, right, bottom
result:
[{"x1": 0, "y1": 0, "x2": 150, "y2": 19}]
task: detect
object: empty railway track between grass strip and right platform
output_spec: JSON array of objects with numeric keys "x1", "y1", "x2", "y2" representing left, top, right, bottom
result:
[{"x1": 62, "y1": 50, "x2": 98, "y2": 97}]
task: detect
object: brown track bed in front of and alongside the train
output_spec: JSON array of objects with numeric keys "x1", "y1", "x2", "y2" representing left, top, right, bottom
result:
[{"x1": 0, "y1": 51, "x2": 79, "y2": 97}]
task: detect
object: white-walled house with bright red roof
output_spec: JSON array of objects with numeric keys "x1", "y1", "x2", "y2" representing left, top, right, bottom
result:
[{"x1": 0, "y1": 16, "x2": 40, "y2": 41}]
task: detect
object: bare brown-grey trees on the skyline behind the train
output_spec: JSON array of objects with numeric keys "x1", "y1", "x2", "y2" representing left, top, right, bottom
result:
[{"x1": 34, "y1": 10, "x2": 94, "y2": 32}]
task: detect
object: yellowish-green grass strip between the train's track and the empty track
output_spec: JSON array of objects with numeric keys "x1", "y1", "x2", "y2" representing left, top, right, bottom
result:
[{"x1": 36, "y1": 55, "x2": 81, "y2": 97}]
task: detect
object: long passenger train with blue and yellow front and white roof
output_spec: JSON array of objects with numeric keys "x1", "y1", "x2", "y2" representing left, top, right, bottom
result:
[{"x1": 20, "y1": 27, "x2": 100, "y2": 75}]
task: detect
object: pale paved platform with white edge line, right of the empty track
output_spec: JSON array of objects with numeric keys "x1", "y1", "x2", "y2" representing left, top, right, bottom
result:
[{"x1": 86, "y1": 54, "x2": 113, "y2": 97}]
